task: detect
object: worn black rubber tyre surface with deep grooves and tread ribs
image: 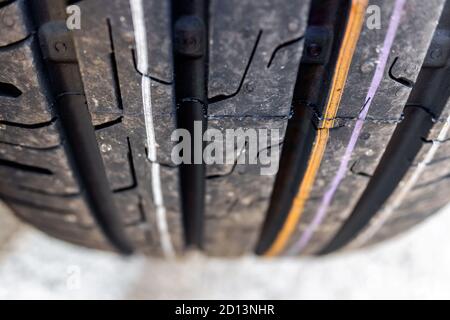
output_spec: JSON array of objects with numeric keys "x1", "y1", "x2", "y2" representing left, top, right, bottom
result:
[{"x1": 0, "y1": 0, "x2": 450, "y2": 257}]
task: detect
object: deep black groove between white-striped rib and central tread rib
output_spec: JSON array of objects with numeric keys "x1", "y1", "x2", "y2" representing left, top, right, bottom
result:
[{"x1": 172, "y1": 0, "x2": 209, "y2": 249}]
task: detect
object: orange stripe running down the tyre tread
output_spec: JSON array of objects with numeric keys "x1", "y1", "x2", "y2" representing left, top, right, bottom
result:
[{"x1": 264, "y1": 0, "x2": 368, "y2": 257}]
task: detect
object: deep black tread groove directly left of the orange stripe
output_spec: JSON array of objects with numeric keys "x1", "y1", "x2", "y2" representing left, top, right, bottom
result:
[{"x1": 256, "y1": 1, "x2": 351, "y2": 254}]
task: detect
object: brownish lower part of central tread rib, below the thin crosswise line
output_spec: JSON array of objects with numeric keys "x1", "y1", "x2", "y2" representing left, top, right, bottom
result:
[{"x1": 205, "y1": 118, "x2": 286, "y2": 256}]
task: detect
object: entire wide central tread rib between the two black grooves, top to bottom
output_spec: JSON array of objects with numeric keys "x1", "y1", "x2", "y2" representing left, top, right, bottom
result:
[{"x1": 205, "y1": 0, "x2": 309, "y2": 256}]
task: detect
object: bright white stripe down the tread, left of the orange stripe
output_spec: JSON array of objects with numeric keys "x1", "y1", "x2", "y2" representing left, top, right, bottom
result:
[{"x1": 130, "y1": 0, "x2": 175, "y2": 257}]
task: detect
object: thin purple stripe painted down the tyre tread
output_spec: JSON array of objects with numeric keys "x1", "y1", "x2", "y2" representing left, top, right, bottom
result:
[{"x1": 289, "y1": 0, "x2": 406, "y2": 254}]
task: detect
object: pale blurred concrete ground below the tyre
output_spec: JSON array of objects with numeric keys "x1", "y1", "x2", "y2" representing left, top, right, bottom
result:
[{"x1": 0, "y1": 200, "x2": 450, "y2": 299}]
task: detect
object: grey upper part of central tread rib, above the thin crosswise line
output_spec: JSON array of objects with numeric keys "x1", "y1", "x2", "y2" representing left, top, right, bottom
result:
[{"x1": 208, "y1": 0, "x2": 309, "y2": 116}]
